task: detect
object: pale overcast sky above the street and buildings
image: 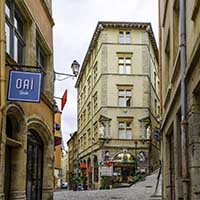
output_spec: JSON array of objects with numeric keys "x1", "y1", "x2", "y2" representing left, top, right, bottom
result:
[{"x1": 52, "y1": 0, "x2": 158, "y2": 147}]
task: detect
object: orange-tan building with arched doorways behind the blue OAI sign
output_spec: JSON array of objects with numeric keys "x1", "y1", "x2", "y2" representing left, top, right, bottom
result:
[{"x1": 0, "y1": 0, "x2": 54, "y2": 200}]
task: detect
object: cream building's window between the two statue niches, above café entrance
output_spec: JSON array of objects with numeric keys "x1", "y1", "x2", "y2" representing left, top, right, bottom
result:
[{"x1": 118, "y1": 119, "x2": 132, "y2": 139}]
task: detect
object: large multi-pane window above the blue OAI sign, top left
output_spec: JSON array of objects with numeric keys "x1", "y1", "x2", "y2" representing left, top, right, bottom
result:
[{"x1": 5, "y1": 0, "x2": 25, "y2": 64}]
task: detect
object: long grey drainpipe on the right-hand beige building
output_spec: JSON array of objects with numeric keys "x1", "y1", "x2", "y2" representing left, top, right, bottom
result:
[{"x1": 179, "y1": 0, "x2": 189, "y2": 200}]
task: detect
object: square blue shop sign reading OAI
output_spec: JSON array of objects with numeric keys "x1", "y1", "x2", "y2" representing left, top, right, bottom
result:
[{"x1": 8, "y1": 71, "x2": 42, "y2": 102}]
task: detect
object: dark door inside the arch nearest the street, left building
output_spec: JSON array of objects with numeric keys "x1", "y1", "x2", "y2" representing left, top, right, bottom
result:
[{"x1": 26, "y1": 129, "x2": 43, "y2": 200}]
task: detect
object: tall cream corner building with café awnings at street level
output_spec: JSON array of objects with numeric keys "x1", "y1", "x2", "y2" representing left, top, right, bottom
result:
[{"x1": 76, "y1": 22, "x2": 160, "y2": 188}]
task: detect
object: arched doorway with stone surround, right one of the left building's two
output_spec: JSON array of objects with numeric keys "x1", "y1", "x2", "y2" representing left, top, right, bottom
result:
[{"x1": 26, "y1": 117, "x2": 54, "y2": 200}]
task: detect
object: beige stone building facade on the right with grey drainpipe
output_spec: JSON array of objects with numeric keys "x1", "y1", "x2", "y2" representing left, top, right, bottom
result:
[{"x1": 159, "y1": 0, "x2": 200, "y2": 200}]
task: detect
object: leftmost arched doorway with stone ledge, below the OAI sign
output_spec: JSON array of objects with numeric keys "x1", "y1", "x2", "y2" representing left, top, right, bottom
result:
[{"x1": 4, "y1": 104, "x2": 25, "y2": 200}]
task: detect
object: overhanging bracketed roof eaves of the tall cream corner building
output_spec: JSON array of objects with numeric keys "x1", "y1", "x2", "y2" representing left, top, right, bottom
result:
[{"x1": 75, "y1": 21, "x2": 158, "y2": 88}]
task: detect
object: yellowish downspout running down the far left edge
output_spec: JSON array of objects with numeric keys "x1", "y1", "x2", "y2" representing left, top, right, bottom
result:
[{"x1": 0, "y1": 0, "x2": 6, "y2": 134}]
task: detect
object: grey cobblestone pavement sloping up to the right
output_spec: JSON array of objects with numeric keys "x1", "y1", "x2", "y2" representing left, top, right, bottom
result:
[{"x1": 54, "y1": 170, "x2": 161, "y2": 200}]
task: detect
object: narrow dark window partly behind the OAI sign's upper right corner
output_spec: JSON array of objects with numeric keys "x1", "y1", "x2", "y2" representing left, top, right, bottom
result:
[{"x1": 36, "y1": 41, "x2": 46, "y2": 92}]
